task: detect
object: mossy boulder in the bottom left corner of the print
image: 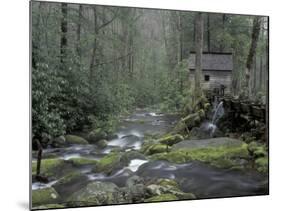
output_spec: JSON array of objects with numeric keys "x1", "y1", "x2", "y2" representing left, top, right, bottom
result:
[{"x1": 32, "y1": 187, "x2": 60, "y2": 206}]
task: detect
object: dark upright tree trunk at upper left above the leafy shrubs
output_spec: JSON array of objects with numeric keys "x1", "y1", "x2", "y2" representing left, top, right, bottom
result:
[{"x1": 60, "y1": 3, "x2": 67, "y2": 68}]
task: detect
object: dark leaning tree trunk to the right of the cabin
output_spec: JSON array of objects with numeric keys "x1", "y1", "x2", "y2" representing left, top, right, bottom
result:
[{"x1": 245, "y1": 16, "x2": 261, "y2": 96}]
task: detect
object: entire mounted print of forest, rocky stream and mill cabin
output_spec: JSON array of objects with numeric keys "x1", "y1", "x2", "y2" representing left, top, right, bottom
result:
[{"x1": 31, "y1": 1, "x2": 269, "y2": 209}]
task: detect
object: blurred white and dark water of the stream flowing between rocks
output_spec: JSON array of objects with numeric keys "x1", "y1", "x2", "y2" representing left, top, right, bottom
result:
[{"x1": 32, "y1": 109, "x2": 267, "y2": 198}]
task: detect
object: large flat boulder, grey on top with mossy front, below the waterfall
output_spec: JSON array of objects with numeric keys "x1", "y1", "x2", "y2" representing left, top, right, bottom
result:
[{"x1": 151, "y1": 138, "x2": 249, "y2": 168}]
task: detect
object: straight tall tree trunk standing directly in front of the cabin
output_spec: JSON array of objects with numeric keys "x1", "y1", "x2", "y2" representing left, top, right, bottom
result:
[{"x1": 195, "y1": 12, "x2": 203, "y2": 97}]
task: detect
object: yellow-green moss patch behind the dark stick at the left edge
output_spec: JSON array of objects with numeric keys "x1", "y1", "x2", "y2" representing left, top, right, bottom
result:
[{"x1": 32, "y1": 158, "x2": 65, "y2": 177}]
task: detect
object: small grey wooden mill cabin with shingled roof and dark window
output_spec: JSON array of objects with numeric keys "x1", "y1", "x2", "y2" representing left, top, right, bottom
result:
[{"x1": 188, "y1": 52, "x2": 233, "y2": 93}]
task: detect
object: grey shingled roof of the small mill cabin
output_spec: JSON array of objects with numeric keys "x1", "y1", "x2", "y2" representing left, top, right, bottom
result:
[{"x1": 188, "y1": 52, "x2": 233, "y2": 71}]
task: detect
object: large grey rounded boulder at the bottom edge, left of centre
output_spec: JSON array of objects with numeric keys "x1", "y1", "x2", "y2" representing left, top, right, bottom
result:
[{"x1": 68, "y1": 182, "x2": 129, "y2": 206}]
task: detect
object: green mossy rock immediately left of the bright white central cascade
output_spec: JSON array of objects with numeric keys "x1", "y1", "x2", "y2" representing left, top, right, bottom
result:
[{"x1": 96, "y1": 152, "x2": 121, "y2": 173}]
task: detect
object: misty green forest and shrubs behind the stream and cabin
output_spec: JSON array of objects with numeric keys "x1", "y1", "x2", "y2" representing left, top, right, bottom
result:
[{"x1": 32, "y1": 2, "x2": 268, "y2": 136}]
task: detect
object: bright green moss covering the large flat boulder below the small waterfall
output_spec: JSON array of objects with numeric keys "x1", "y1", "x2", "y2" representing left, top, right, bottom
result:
[{"x1": 152, "y1": 144, "x2": 248, "y2": 168}]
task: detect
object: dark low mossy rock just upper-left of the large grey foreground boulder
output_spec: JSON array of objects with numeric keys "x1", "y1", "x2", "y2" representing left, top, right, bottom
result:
[{"x1": 53, "y1": 171, "x2": 88, "y2": 198}]
